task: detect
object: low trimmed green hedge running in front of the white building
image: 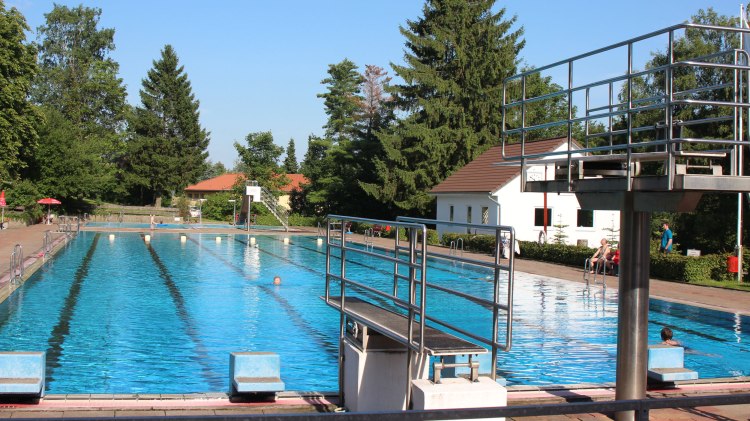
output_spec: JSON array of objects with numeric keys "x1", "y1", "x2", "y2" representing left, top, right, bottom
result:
[{"x1": 442, "y1": 233, "x2": 750, "y2": 283}]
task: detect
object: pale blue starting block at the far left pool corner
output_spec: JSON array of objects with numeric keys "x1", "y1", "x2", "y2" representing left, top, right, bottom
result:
[{"x1": 0, "y1": 352, "x2": 46, "y2": 398}]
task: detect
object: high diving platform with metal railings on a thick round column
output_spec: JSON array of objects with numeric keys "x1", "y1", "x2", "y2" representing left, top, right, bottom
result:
[{"x1": 498, "y1": 19, "x2": 750, "y2": 421}]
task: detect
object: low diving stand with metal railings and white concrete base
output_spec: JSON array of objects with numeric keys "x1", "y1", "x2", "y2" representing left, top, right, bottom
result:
[{"x1": 321, "y1": 215, "x2": 515, "y2": 412}]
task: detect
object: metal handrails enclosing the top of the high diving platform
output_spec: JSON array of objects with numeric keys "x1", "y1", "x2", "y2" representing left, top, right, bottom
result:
[{"x1": 501, "y1": 24, "x2": 750, "y2": 191}]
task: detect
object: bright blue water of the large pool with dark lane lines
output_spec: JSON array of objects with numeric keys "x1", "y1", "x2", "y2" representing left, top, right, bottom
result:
[{"x1": 0, "y1": 231, "x2": 750, "y2": 393}]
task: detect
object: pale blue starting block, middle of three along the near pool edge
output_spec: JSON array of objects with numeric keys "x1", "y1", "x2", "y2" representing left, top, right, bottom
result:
[{"x1": 229, "y1": 352, "x2": 284, "y2": 396}]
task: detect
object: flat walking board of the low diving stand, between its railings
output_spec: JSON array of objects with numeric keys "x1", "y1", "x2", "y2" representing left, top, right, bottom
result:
[{"x1": 328, "y1": 297, "x2": 487, "y2": 357}]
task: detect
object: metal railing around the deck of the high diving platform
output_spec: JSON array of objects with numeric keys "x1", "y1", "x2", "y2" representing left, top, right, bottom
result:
[{"x1": 502, "y1": 24, "x2": 750, "y2": 191}]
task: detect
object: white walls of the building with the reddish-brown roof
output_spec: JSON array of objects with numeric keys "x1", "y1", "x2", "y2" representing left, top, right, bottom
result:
[{"x1": 437, "y1": 169, "x2": 620, "y2": 248}]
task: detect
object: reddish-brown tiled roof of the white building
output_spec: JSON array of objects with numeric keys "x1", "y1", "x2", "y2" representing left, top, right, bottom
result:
[{"x1": 430, "y1": 137, "x2": 567, "y2": 194}]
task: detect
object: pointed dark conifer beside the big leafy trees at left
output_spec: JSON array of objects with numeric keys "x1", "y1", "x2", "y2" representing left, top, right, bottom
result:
[{"x1": 125, "y1": 45, "x2": 209, "y2": 206}]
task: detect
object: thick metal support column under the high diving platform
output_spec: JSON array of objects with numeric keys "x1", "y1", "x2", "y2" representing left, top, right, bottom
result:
[{"x1": 615, "y1": 192, "x2": 651, "y2": 421}]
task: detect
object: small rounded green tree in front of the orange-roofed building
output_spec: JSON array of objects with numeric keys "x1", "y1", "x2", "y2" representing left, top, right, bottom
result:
[{"x1": 234, "y1": 132, "x2": 289, "y2": 193}]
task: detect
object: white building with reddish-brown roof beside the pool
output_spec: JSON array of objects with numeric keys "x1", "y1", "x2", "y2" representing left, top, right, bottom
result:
[{"x1": 430, "y1": 138, "x2": 620, "y2": 247}]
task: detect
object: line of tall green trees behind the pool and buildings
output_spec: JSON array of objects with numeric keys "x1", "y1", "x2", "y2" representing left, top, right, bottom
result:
[{"x1": 0, "y1": 0, "x2": 736, "y2": 253}]
